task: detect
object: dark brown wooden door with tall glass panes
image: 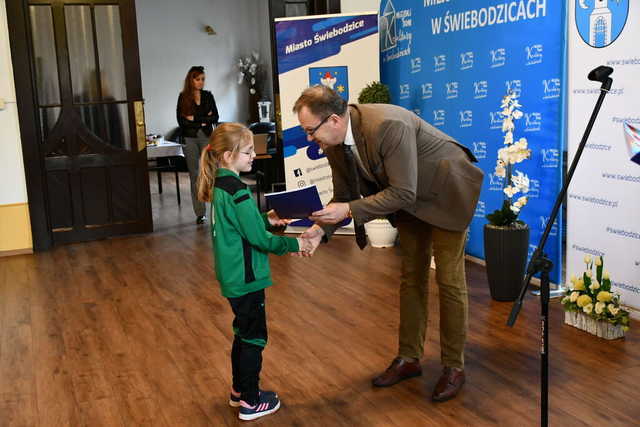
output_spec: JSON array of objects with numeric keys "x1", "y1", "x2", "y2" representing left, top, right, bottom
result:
[{"x1": 7, "y1": 0, "x2": 153, "y2": 250}]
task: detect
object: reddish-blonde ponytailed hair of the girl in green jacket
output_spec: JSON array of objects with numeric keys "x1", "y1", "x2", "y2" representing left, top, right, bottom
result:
[{"x1": 198, "y1": 123, "x2": 253, "y2": 202}]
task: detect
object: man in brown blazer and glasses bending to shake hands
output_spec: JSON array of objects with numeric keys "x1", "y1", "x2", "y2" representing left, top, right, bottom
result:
[{"x1": 293, "y1": 86, "x2": 483, "y2": 401}]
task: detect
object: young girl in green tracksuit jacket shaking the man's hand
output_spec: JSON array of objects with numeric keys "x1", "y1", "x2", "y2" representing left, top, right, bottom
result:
[{"x1": 198, "y1": 123, "x2": 312, "y2": 420}]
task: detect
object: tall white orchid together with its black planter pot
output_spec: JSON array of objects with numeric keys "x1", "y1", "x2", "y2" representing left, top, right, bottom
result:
[{"x1": 484, "y1": 92, "x2": 531, "y2": 301}]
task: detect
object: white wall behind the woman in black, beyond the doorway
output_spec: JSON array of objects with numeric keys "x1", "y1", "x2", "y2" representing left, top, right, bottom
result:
[{"x1": 136, "y1": 0, "x2": 272, "y2": 134}]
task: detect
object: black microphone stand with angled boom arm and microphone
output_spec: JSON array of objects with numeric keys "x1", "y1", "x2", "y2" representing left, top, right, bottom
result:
[{"x1": 507, "y1": 65, "x2": 613, "y2": 427}]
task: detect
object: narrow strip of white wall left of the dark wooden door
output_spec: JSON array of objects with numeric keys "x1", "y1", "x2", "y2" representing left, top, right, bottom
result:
[{"x1": 0, "y1": 0, "x2": 27, "y2": 205}]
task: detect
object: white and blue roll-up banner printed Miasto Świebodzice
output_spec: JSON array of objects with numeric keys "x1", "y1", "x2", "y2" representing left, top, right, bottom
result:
[{"x1": 275, "y1": 11, "x2": 380, "y2": 231}]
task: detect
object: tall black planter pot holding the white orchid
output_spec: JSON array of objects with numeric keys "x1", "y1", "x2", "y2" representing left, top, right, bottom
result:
[{"x1": 484, "y1": 224, "x2": 529, "y2": 301}]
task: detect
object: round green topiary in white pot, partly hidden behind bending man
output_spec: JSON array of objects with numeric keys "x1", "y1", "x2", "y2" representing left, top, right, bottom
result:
[{"x1": 358, "y1": 81, "x2": 398, "y2": 248}]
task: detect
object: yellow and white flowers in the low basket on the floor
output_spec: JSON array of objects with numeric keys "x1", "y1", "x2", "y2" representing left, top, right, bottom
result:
[{"x1": 561, "y1": 255, "x2": 629, "y2": 331}]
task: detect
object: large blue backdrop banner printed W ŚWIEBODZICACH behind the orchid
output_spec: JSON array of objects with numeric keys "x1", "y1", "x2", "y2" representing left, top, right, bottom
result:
[{"x1": 380, "y1": 0, "x2": 566, "y2": 283}]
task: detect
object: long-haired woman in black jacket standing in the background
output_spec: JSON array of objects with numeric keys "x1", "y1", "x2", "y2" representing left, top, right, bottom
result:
[{"x1": 176, "y1": 66, "x2": 219, "y2": 224}]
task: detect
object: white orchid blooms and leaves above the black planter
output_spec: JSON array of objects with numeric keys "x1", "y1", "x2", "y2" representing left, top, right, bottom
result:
[{"x1": 487, "y1": 91, "x2": 531, "y2": 227}]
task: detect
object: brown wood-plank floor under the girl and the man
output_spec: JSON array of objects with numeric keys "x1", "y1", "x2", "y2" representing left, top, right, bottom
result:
[{"x1": 0, "y1": 174, "x2": 640, "y2": 426}]
